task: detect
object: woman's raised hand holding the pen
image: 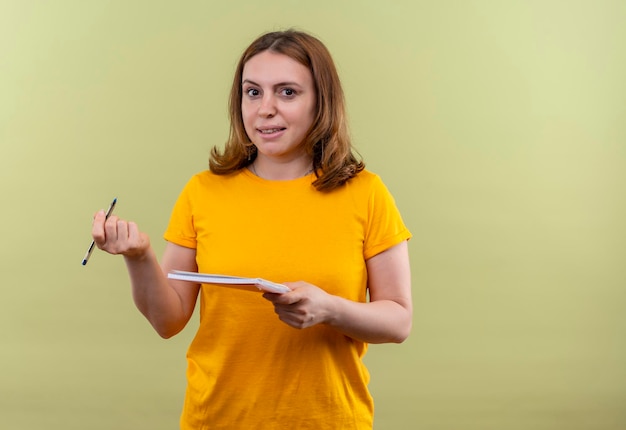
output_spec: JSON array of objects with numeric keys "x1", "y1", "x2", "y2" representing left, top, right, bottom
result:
[{"x1": 91, "y1": 210, "x2": 150, "y2": 259}]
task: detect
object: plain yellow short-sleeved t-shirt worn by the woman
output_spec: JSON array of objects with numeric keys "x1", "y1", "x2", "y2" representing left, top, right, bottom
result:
[{"x1": 164, "y1": 169, "x2": 410, "y2": 430}]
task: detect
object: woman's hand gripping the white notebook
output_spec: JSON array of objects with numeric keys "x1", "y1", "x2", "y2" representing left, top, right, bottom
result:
[{"x1": 263, "y1": 281, "x2": 333, "y2": 329}]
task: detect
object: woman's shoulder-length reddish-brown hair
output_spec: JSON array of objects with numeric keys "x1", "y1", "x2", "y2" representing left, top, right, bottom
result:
[{"x1": 209, "y1": 30, "x2": 365, "y2": 191}]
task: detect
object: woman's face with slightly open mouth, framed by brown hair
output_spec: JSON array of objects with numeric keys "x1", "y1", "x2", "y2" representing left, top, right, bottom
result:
[{"x1": 241, "y1": 51, "x2": 316, "y2": 161}]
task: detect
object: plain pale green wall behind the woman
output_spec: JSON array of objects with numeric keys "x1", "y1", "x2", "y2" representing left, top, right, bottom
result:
[{"x1": 0, "y1": 0, "x2": 626, "y2": 430}]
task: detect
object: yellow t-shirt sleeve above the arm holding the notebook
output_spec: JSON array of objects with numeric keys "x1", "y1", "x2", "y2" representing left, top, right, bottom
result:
[{"x1": 363, "y1": 176, "x2": 411, "y2": 260}]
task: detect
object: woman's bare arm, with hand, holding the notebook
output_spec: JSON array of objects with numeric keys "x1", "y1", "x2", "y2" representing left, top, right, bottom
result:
[{"x1": 264, "y1": 241, "x2": 413, "y2": 343}]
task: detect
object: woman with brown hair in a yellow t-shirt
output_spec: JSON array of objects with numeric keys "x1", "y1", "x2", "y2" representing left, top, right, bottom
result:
[{"x1": 92, "y1": 31, "x2": 412, "y2": 430}]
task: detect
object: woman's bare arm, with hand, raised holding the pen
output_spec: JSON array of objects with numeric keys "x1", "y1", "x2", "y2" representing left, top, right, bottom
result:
[{"x1": 92, "y1": 211, "x2": 200, "y2": 338}]
